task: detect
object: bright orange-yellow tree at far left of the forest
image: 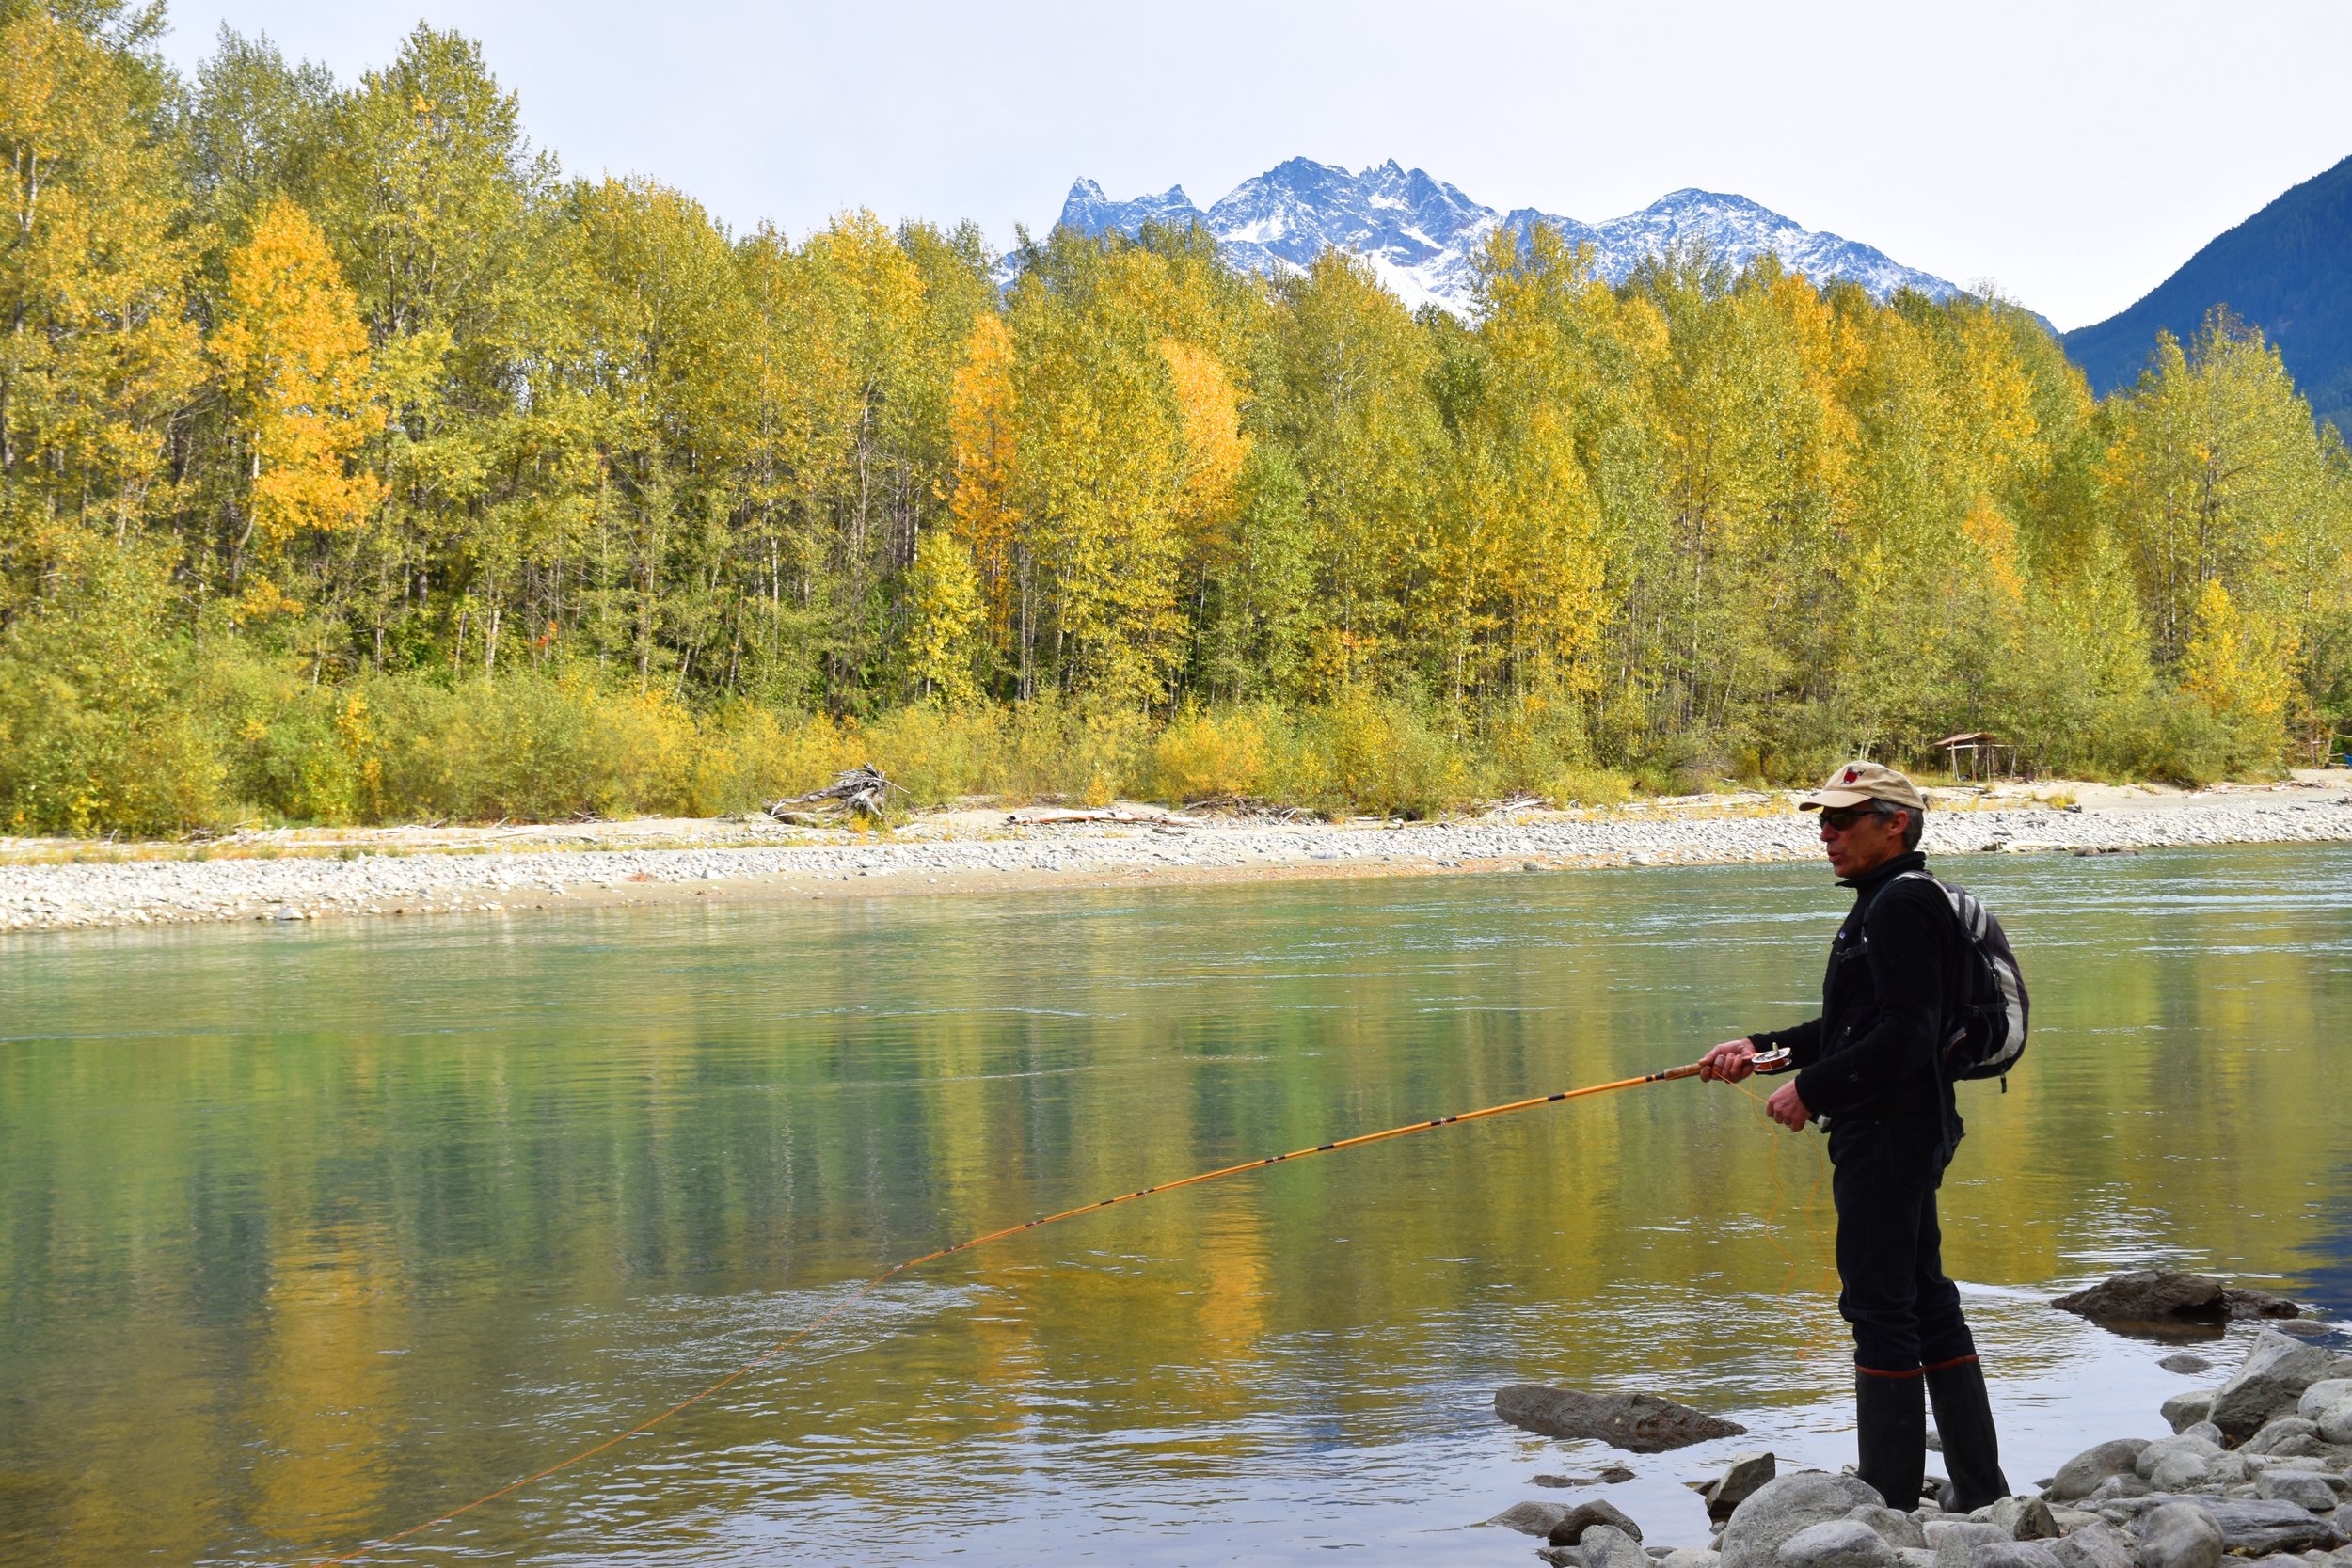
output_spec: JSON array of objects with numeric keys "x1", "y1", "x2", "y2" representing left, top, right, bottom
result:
[{"x1": 212, "y1": 199, "x2": 384, "y2": 566}]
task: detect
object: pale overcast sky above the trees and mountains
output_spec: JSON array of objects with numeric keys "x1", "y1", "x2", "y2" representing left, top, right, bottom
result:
[{"x1": 167, "y1": 0, "x2": 2352, "y2": 326}]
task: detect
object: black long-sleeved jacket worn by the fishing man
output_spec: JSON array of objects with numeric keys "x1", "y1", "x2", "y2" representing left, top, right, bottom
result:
[{"x1": 1750, "y1": 851, "x2": 1964, "y2": 1143}]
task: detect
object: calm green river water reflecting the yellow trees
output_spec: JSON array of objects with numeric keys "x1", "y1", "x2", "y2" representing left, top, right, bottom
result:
[{"x1": 0, "y1": 848, "x2": 2352, "y2": 1566}]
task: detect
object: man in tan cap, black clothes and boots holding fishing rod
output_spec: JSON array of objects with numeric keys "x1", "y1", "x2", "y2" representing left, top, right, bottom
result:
[{"x1": 1701, "y1": 762, "x2": 2009, "y2": 1512}]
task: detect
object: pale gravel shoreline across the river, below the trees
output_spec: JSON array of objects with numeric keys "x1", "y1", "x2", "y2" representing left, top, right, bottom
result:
[{"x1": 0, "y1": 771, "x2": 2352, "y2": 931}]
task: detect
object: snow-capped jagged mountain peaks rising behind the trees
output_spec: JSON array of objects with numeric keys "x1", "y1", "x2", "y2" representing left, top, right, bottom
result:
[{"x1": 1061, "y1": 157, "x2": 1962, "y2": 315}]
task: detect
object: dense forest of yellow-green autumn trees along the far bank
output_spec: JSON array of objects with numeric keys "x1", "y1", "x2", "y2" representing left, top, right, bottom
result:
[{"x1": 0, "y1": 0, "x2": 2352, "y2": 832}]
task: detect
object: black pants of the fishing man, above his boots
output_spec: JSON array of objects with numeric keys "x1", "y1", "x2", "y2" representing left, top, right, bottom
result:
[{"x1": 1830, "y1": 1121, "x2": 1976, "y2": 1375}]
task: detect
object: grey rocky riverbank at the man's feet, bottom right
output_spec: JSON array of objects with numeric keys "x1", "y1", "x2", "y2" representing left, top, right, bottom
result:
[{"x1": 1489, "y1": 1328, "x2": 2352, "y2": 1568}]
